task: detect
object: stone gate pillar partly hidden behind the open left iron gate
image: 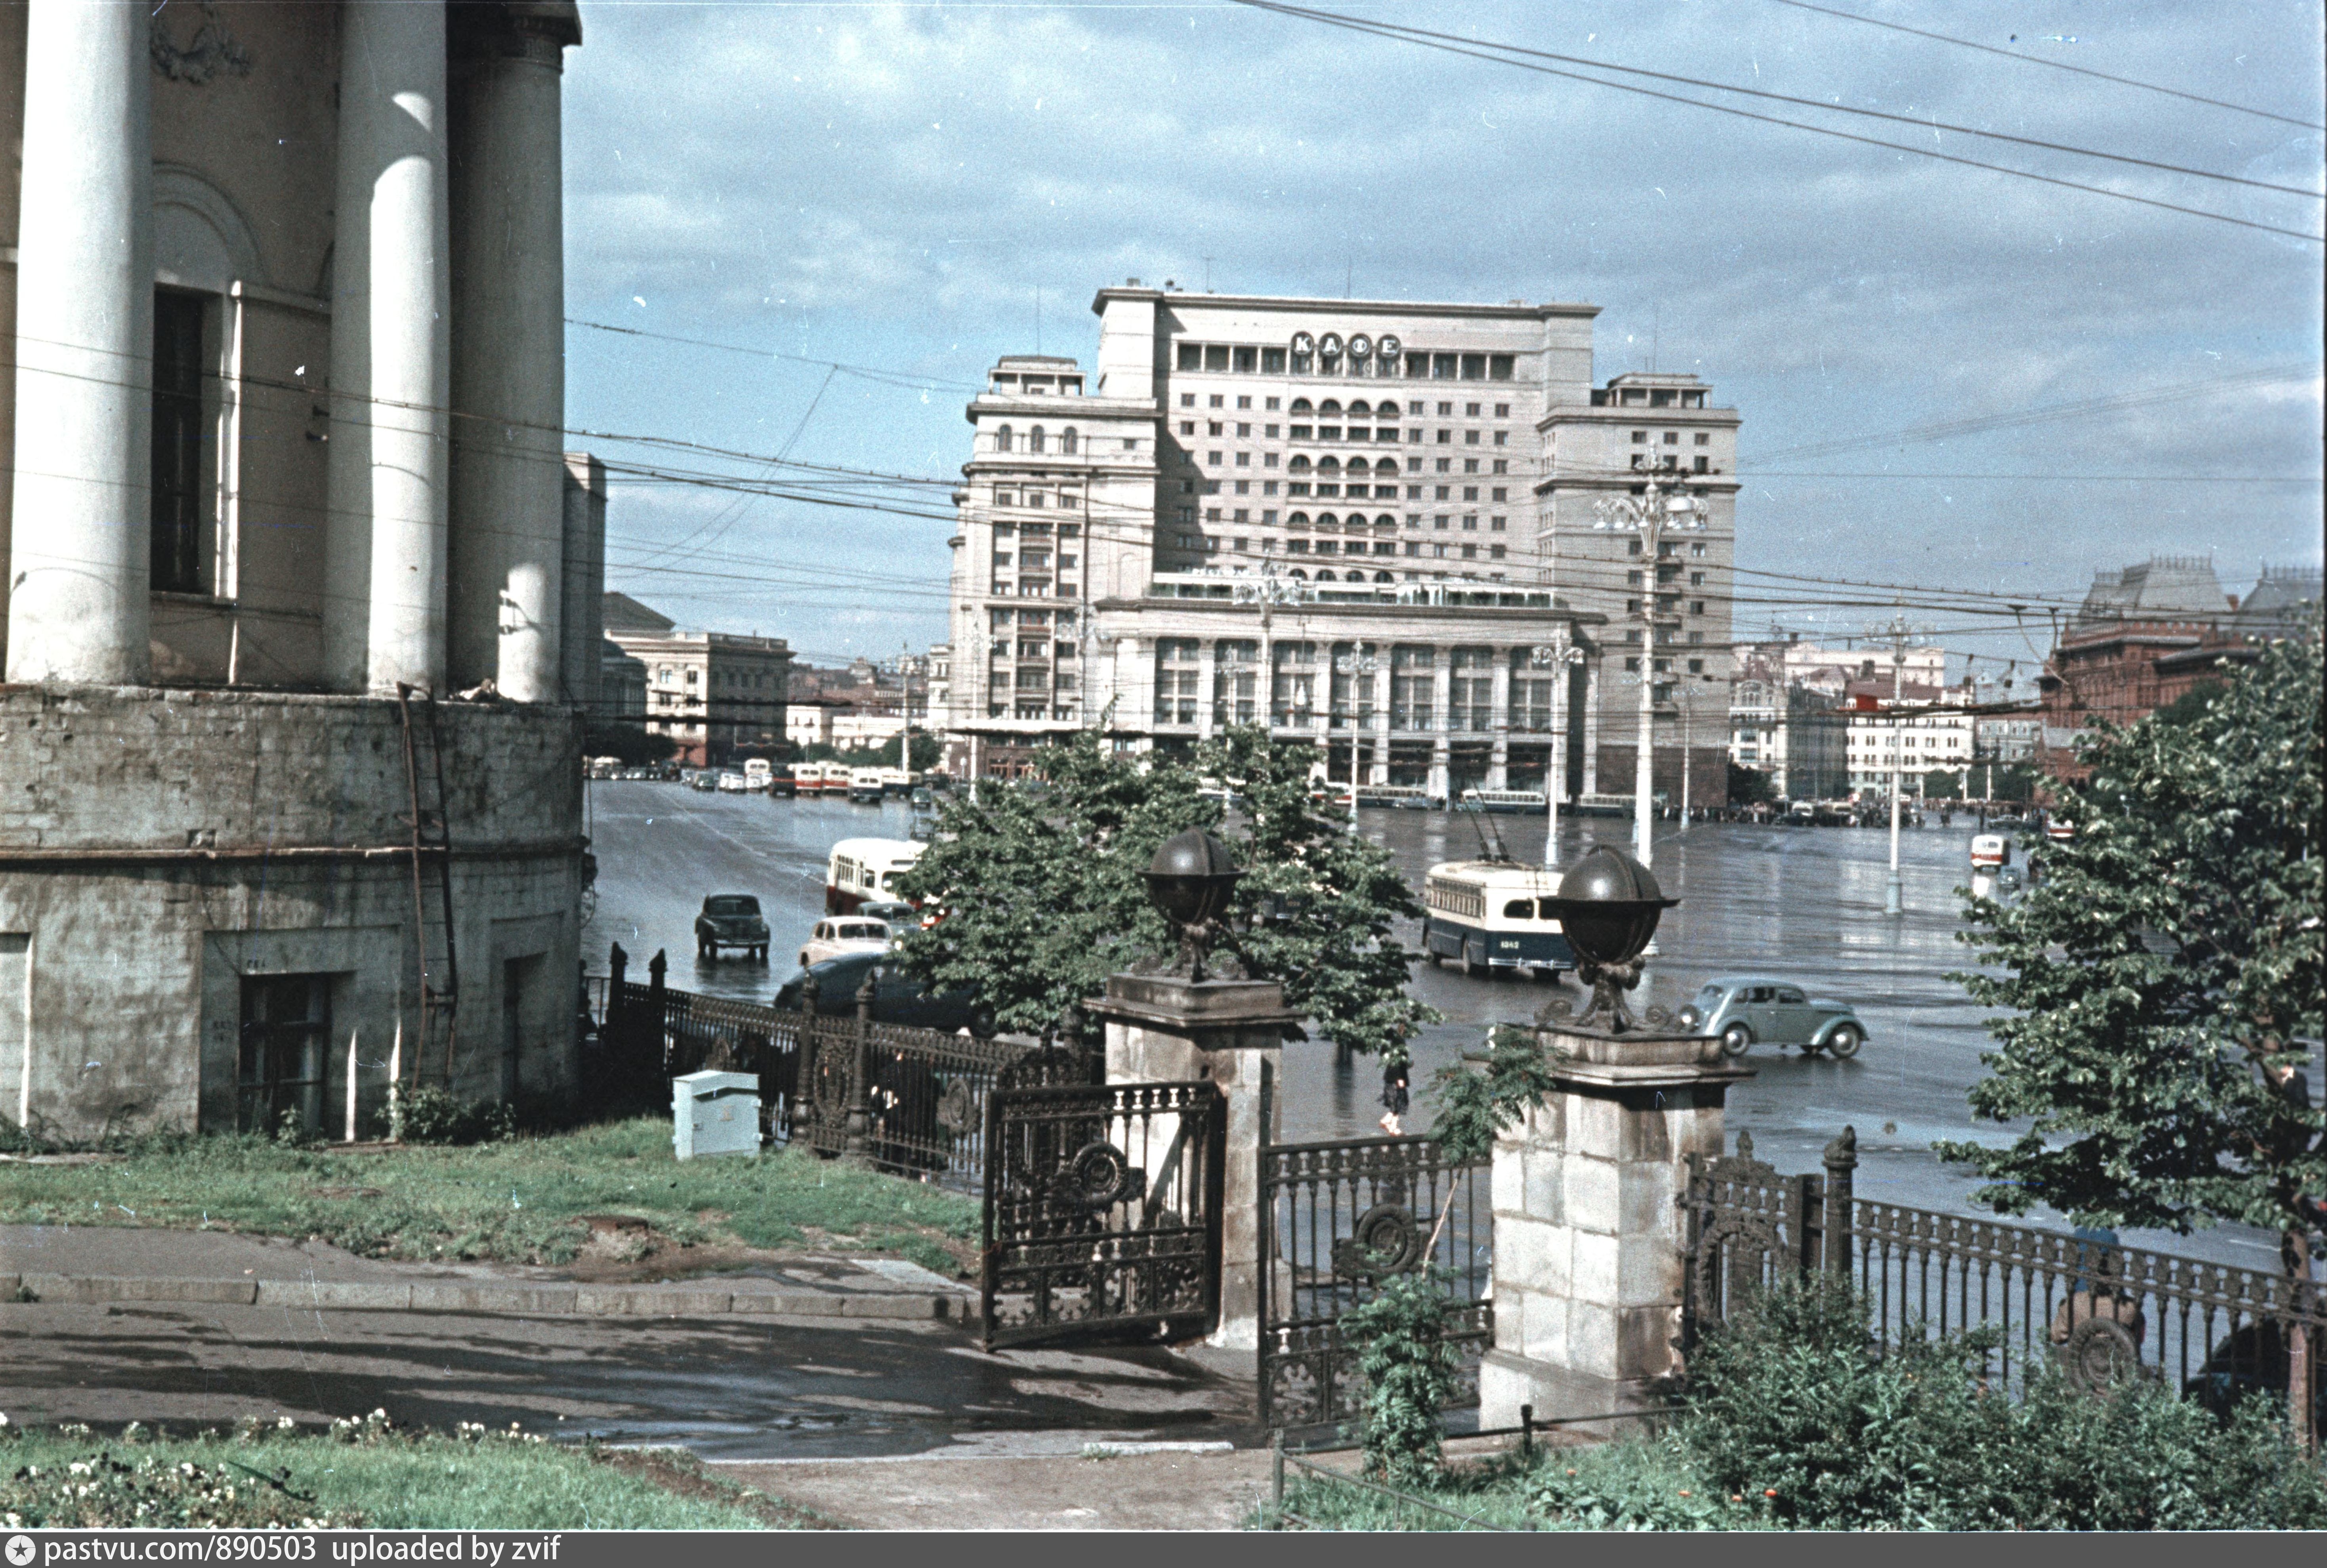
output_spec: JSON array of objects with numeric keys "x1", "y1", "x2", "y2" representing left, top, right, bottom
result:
[{"x1": 1084, "y1": 975, "x2": 1298, "y2": 1349}]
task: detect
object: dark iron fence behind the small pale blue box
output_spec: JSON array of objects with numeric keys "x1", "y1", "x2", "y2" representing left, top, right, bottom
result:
[{"x1": 589, "y1": 949, "x2": 1056, "y2": 1191}]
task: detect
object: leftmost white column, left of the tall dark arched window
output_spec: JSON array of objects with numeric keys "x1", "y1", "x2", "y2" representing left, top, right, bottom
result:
[{"x1": 7, "y1": 0, "x2": 154, "y2": 684}]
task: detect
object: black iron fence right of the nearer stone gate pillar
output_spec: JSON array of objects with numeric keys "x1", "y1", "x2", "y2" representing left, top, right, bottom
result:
[{"x1": 1685, "y1": 1128, "x2": 2327, "y2": 1415}]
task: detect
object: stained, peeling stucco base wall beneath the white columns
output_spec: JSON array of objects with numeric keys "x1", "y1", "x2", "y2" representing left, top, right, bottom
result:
[{"x1": 0, "y1": 686, "x2": 584, "y2": 1138}]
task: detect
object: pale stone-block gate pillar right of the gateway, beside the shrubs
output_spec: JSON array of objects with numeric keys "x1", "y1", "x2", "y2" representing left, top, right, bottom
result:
[{"x1": 1478, "y1": 1026, "x2": 1752, "y2": 1426}]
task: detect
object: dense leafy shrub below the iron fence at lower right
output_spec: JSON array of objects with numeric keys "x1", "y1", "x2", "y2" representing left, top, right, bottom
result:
[{"x1": 1676, "y1": 1280, "x2": 2327, "y2": 1531}]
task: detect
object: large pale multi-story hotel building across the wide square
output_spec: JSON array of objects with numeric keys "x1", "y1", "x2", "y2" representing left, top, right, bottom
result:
[{"x1": 949, "y1": 279, "x2": 1738, "y2": 802}]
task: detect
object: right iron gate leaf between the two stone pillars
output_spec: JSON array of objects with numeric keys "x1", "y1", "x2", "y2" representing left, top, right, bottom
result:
[{"x1": 1259, "y1": 1138, "x2": 1494, "y2": 1426}]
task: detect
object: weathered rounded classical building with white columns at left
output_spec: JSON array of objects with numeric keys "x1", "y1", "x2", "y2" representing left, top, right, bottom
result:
[{"x1": 0, "y1": 0, "x2": 605, "y2": 1138}]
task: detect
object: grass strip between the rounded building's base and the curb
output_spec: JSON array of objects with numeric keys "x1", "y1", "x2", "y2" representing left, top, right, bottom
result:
[{"x1": 0, "y1": 1117, "x2": 980, "y2": 1275}]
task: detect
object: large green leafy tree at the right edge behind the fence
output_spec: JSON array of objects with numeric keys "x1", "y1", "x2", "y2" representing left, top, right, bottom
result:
[{"x1": 1938, "y1": 619, "x2": 2327, "y2": 1435}]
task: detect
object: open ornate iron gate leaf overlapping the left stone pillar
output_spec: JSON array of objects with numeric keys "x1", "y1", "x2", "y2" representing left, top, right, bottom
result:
[{"x1": 982, "y1": 1082, "x2": 1229, "y2": 1349}]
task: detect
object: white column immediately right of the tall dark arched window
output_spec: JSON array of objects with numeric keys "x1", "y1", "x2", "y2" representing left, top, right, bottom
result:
[{"x1": 323, "y1": 0, "x2": 451, "y2": 691}]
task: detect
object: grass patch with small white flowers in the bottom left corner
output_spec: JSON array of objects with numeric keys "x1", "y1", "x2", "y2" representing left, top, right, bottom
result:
[{"x1": 0, "y1": 1419, "x2": 819, "y2": 1531}]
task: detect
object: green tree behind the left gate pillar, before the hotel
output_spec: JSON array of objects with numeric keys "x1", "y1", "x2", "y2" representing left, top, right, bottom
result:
[{"x1": 903, "y1": 728, "x2": 1438, "y2": 1061}]
